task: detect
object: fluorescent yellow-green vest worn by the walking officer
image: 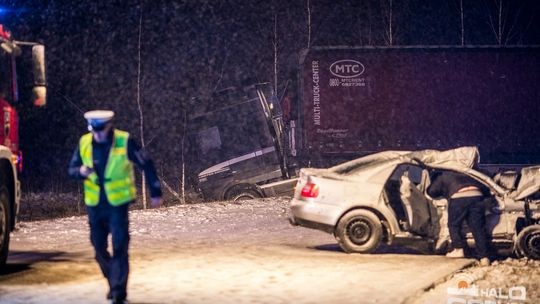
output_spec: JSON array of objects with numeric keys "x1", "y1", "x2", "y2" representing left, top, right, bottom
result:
[{"x1": 79, "y1": 130, "x2": 137, "y2": 206}]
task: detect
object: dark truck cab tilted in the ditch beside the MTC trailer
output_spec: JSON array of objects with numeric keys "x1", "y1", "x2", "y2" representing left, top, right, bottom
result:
[{"x1": 186, "y1": 83, "x2": 296, "y2": 200}]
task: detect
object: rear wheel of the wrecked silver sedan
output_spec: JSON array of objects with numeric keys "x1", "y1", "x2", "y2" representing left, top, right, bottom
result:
[{"x1": 335, "y1": 209, "x2": 383, "y2": 253}]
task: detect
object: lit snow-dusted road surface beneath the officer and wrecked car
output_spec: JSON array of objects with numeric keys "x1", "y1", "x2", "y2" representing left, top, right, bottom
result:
[{"x1": 0, "y1": 198, "x2": 536, "y2": 303}]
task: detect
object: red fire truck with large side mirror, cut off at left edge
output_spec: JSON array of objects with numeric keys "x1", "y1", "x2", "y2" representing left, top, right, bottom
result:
[{"x1": 0, "y1": 24, "x2": 47, "y2": 268}]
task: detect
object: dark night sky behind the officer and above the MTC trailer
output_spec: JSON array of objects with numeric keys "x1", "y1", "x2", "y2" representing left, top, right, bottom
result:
[{"x1": 0, "y1": 0, "x2": 540, "y2": 191}]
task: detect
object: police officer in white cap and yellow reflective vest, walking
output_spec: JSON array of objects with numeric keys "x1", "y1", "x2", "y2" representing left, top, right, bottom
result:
[{"x1": 69, "y1": 110, "x2": 161, "y2": 303}]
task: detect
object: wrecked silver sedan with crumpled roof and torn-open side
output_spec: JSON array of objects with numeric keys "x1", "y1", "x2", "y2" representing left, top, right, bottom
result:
[{"x1": 290, "y1": 147, "x2": 540, "y2": 259}]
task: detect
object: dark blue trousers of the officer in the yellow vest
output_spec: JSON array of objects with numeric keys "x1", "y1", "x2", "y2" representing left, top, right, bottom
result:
[{"x1": 88, "y1": 202, "x2": 129, "y2": 300}]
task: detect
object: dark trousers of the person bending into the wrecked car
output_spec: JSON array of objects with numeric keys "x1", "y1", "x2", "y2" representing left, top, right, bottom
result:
[{"x1": 448, "y1": 196, "x2": 488, "y2": 258}]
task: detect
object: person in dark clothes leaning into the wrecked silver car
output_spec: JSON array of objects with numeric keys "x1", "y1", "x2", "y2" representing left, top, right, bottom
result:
[{"x1": 427, "y1": 171, "x2": 489, "y2": 265}]
